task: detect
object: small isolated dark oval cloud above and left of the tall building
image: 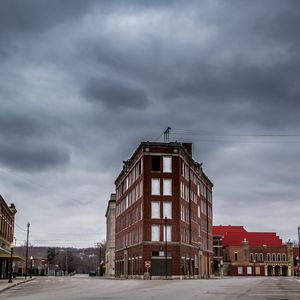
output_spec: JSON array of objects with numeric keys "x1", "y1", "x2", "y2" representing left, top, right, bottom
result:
[{"x1": 83, "y1": 78, "x2": 149, "y2": 111}]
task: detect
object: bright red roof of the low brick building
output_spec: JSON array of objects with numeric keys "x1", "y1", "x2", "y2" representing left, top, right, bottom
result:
[{"x1": 213, "y1": 226, "x2": 283, "y2": 247}]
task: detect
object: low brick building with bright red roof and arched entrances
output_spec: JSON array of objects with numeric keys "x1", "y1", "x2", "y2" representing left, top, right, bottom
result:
[{"x1": 213, "y1": 226, "x2": 294, "y2": 276}]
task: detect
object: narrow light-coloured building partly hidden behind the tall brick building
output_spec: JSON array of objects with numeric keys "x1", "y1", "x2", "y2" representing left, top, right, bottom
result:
[{"x1": 105, "y1": 194, "x2": 116, "y2": 276}]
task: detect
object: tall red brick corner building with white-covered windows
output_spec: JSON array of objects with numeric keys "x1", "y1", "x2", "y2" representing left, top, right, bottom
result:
[{"x1": 115, "y1": 142, "x2": 213, "y2": 278}]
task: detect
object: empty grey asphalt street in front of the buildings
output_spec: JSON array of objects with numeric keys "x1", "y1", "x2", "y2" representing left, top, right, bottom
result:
[{"x1": 0, "y1": 276, "x2": 300, "y2": 300}]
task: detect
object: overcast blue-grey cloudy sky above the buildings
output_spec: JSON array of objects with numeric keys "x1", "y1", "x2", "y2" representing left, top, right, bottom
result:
[{"x1": 0, "y1": 0, "x2": 300, "y2": 247}]
